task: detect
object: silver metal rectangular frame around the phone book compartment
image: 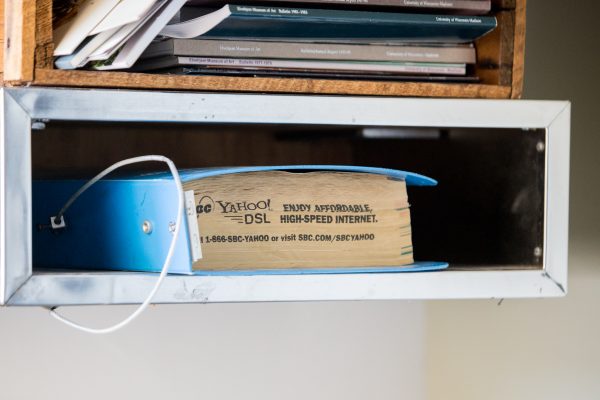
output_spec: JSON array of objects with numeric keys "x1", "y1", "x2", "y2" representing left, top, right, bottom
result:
[{"x1": 0, "y1": 88, "x2": 570, "y2": 306}]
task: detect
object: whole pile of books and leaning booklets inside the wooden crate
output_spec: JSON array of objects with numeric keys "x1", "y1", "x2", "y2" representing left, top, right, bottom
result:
[{"x1": 54, "y1": 0, "x2": 496, "y2": 81}]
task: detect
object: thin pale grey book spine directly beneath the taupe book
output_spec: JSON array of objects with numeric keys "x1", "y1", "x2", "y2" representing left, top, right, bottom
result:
[{"x1": 177, "y1": 57, "x2": 466, "y2": 75}]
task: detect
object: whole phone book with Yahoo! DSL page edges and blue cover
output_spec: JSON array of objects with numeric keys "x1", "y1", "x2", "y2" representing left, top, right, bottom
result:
[{"x1": 33, "y1": 165, "x2": 447, "y2": 275}]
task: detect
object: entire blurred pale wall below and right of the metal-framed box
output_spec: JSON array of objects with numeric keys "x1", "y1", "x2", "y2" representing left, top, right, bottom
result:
[{"x1": 0, "y1": 0, "x2": 600, "y2": 400}]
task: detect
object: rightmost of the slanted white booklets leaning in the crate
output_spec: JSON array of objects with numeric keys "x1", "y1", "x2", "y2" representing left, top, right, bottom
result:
[{"x1": 93, "y1": 0, "x2": 187, "y2": 70}]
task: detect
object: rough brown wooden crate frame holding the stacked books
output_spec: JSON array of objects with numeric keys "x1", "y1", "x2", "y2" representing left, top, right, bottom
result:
[{"x1": 0, "y1": 0, "x2": 525, "y2": 98}]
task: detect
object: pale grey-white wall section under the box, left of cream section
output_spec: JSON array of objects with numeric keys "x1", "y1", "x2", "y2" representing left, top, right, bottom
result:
[{"x1": 0, "y1": 302, "x2": 424, "y2": 400}]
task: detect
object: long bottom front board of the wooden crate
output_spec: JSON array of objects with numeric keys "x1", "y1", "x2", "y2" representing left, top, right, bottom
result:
[{"x1": 31, "y1": 69, "x2": 511, "y2": 99}]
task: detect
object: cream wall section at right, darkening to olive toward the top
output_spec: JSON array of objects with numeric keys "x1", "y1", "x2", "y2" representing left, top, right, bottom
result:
[{"x1": 426, "y1": 0, "x2": 600, "y2": 400}]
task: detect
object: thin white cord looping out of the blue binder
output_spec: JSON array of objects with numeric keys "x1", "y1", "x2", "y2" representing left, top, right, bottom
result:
[{"x1": 50, "y1": 155, "x2": 184, "y2": 334}]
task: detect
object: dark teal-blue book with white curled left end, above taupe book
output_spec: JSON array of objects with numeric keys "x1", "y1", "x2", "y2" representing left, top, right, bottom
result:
[{"x1": 160, "y1": 5, "x2": 497, "y2": 43}]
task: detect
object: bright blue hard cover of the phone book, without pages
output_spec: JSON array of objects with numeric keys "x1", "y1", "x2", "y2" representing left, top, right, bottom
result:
[{"x1": 33, "y1": 165, "x2": 448, "y2": 275}]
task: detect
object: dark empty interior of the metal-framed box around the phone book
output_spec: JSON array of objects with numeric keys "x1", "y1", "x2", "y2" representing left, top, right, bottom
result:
[{"x1": 32, "y1": 121, "x2": 545, "y2": 269}]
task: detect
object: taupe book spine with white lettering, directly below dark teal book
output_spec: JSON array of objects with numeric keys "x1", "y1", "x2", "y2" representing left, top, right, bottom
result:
[{"x1": 172, "y1": 39, "x2": 475, "y2": 64}]
